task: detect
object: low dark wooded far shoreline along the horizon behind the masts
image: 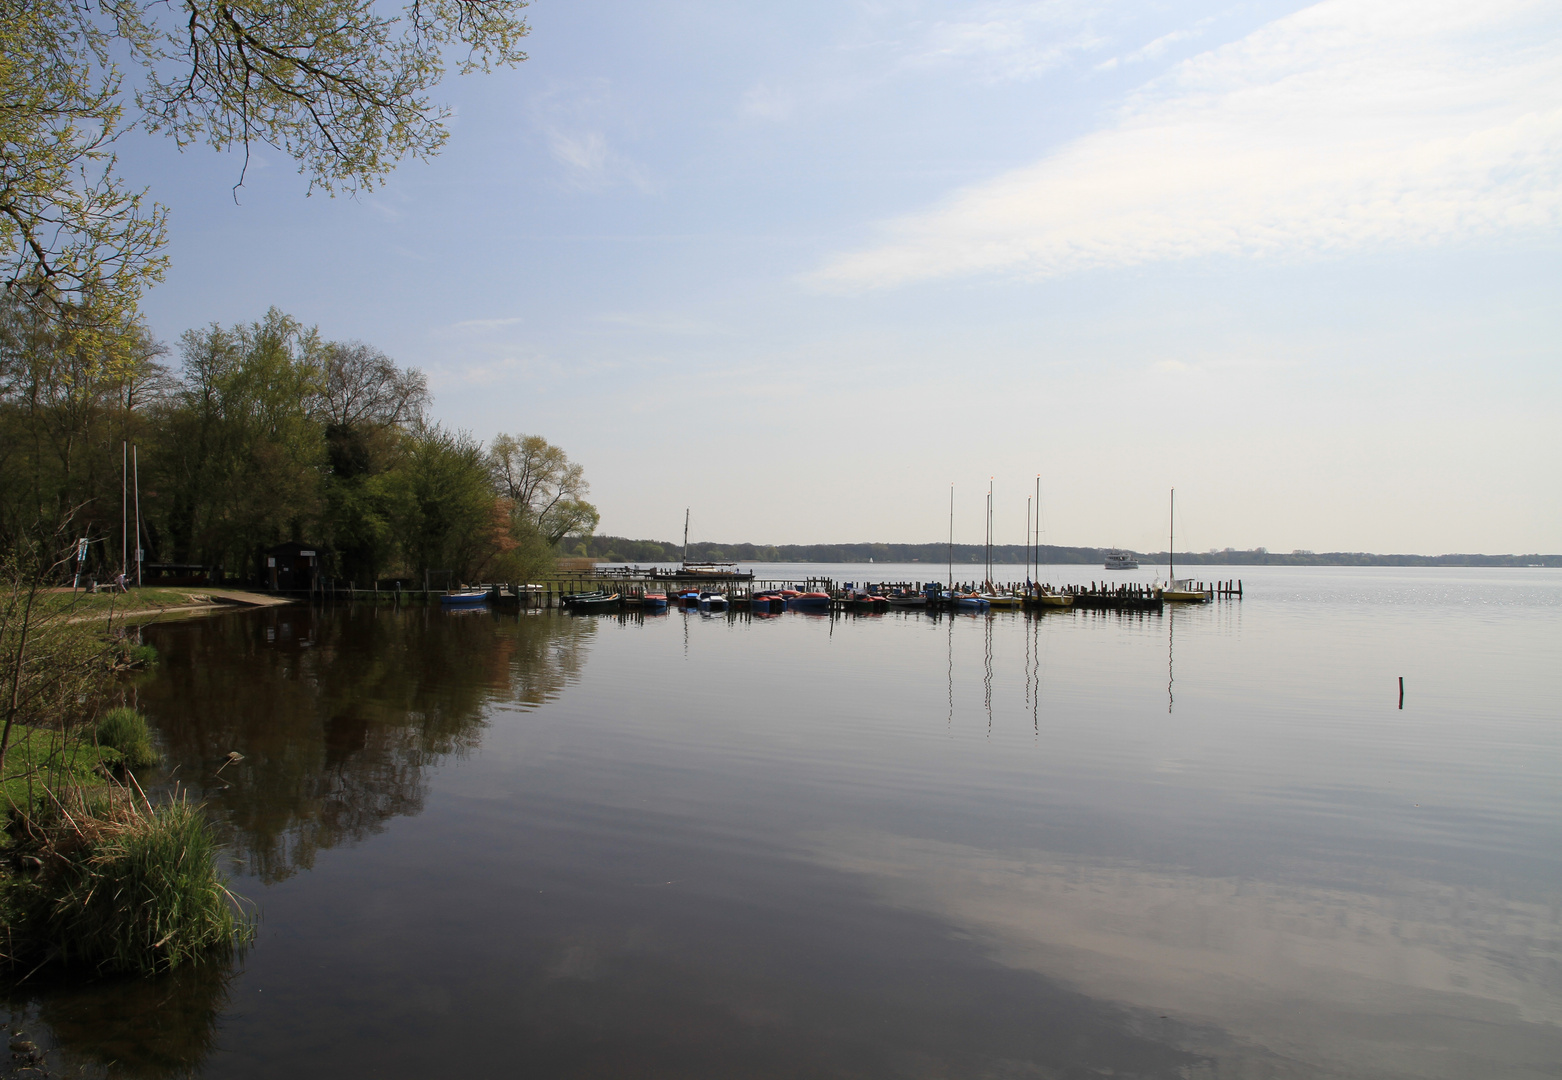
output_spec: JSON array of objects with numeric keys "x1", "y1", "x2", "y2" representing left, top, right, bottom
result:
[{"x1": 574, "y1": 536, "x2": 1562, "y2": 567}]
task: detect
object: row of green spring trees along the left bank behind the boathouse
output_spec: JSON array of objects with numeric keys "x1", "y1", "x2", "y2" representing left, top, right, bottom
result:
[{"x1": 0, "y1": 305, "x2": 598, "y2": 583}]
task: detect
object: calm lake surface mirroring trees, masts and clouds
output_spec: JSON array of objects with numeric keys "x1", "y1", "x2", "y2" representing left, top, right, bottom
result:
[{"x1": 11, "y1": 566, "x2": 1562, "y2": 1078}]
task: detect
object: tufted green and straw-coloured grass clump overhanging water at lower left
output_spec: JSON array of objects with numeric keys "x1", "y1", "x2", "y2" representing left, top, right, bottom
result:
[{"x1": 3, "y1": 785, "x2": 255, "y2": 975}]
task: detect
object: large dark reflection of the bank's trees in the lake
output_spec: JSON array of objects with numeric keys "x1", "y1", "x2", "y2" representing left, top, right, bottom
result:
[{"x1": 137, "y1": 606, "x2": 595, "y2": 882}]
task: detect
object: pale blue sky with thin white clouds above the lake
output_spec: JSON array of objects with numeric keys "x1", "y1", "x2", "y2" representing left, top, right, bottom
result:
[{"x1": 122, "y1": 0, "x2": 1562, "y2": 553}]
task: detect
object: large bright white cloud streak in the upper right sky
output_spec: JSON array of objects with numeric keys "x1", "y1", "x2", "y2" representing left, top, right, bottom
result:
[{"x1": 812, "y1": 0, "x2": 1562, "y2": 289}]
